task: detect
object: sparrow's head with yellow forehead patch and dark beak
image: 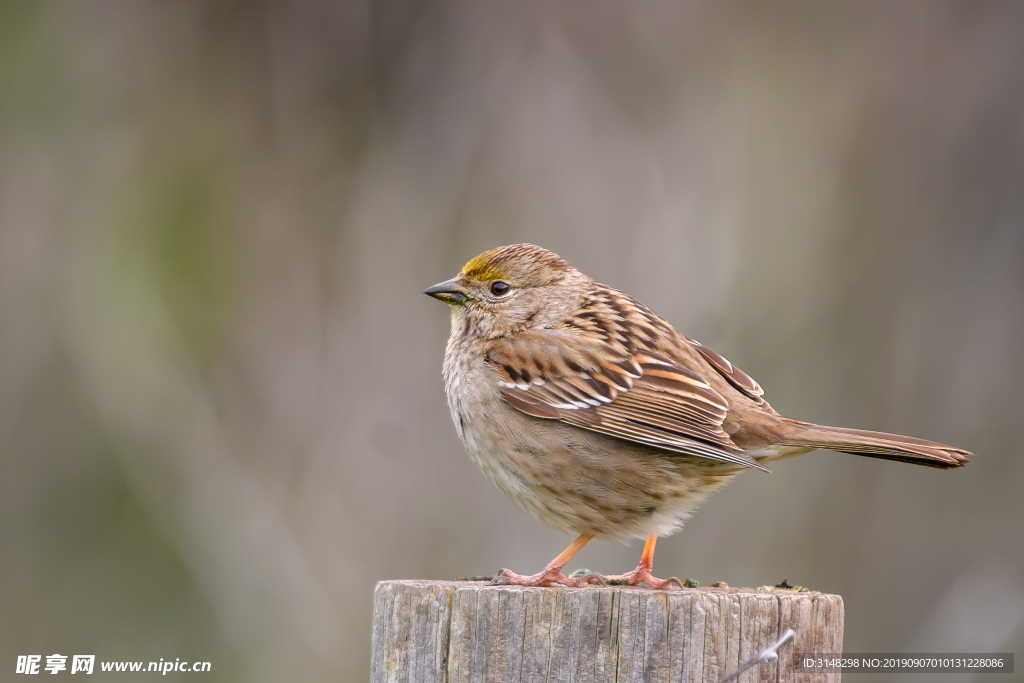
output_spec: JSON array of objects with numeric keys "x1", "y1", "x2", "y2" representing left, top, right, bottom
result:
[{"x1": 424, "y1": 244, "x2": 590, "y2": 338}]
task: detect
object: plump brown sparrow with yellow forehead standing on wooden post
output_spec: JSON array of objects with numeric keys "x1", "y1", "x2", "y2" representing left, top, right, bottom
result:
[{"x1": 424, "y1": 244, "x2": 972, "y2": 589}]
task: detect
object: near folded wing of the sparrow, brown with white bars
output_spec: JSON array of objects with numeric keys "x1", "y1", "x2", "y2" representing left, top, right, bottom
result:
[{"x1": 487, "y1": 331, "x2": 763, "y2": 469}]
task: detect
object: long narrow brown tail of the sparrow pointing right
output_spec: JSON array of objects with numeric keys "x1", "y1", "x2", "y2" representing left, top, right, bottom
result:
[{"x1": 781, "y1": 419, "x2": 973, "y2": 469}]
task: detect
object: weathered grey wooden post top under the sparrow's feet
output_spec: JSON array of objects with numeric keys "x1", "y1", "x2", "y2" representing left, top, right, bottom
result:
[{"x1": 371, "y1": 581, "x2": 843, "y2": 683}]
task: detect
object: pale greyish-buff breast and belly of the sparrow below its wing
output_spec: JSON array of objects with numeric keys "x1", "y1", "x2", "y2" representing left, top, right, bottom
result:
[{"x1": 445, "y1": 348, "x2": 742, "y2": 541}]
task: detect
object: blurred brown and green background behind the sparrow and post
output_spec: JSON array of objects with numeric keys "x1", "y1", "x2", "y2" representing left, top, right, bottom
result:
[{"x1": 0, "y1": 0, "x2": 1024, "y2": 682}]
